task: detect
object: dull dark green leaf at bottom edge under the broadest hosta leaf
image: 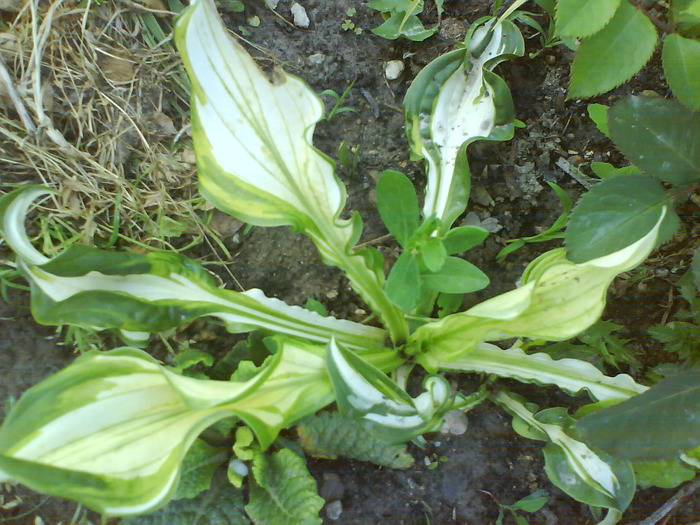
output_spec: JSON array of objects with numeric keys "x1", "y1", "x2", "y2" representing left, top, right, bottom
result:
[{"x1": 119, "y1": 478, "x2": 250, "y2": 525}]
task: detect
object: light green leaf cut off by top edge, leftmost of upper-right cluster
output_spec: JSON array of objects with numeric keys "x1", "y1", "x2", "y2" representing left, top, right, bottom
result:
[{"x1": 556, "y1": 0, "x2": 620, "y2": 38}]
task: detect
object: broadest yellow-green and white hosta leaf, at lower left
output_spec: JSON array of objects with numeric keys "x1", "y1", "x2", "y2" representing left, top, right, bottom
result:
[{"x1": 0, "y1": 338, "x2": 333, "y2": 516}]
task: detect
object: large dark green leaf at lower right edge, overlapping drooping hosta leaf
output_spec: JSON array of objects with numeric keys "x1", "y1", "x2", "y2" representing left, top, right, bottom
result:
[{"x1": 576, "y1": 369, "x2": 700, "y2": 461}]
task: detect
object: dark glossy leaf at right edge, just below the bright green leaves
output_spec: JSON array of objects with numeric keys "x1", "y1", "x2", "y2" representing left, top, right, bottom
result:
[{"x1": 608, "y1": 97, "x2": 700, "y2": 184}]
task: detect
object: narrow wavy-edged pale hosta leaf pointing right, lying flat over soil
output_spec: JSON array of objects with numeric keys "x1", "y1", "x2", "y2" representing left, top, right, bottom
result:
[{"x1": 437, "y1": 343, "x2": 647, "y2": 401}]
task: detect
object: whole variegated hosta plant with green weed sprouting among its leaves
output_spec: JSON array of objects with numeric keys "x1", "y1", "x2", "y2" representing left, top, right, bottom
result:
[{"x1": 0, "y1": 0, "x2": 688, "y2": 523}]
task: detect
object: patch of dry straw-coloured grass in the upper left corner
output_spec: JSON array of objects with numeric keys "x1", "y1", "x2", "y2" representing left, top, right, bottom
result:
[{"x1": 0, "y1": 0, "x2": 224, "y2": 256}]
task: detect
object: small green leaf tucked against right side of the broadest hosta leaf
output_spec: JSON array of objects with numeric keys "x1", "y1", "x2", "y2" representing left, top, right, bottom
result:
[{"x1": 173, "y1": 439, "x2": 226, "y2": 499}]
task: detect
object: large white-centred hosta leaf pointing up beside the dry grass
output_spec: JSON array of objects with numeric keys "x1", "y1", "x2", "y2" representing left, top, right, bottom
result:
[{"x1": 175, "y1": 0, "x2": 407, "y2": 340}]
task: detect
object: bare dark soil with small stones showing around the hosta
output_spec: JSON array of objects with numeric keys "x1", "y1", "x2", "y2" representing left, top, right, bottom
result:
[{"x1": 0, "y1": 0, "x2": 700, "y2": 525}]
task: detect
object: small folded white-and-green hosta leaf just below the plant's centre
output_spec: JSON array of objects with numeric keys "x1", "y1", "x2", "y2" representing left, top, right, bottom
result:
[{"x1": 327, "y1": 341, "x2": 453, "y2": 443}]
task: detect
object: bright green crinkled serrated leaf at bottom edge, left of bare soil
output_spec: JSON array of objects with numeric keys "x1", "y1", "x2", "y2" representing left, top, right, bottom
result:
[{"x1": 245, "y1": 448, "x2": 325, "y2": 525}]
